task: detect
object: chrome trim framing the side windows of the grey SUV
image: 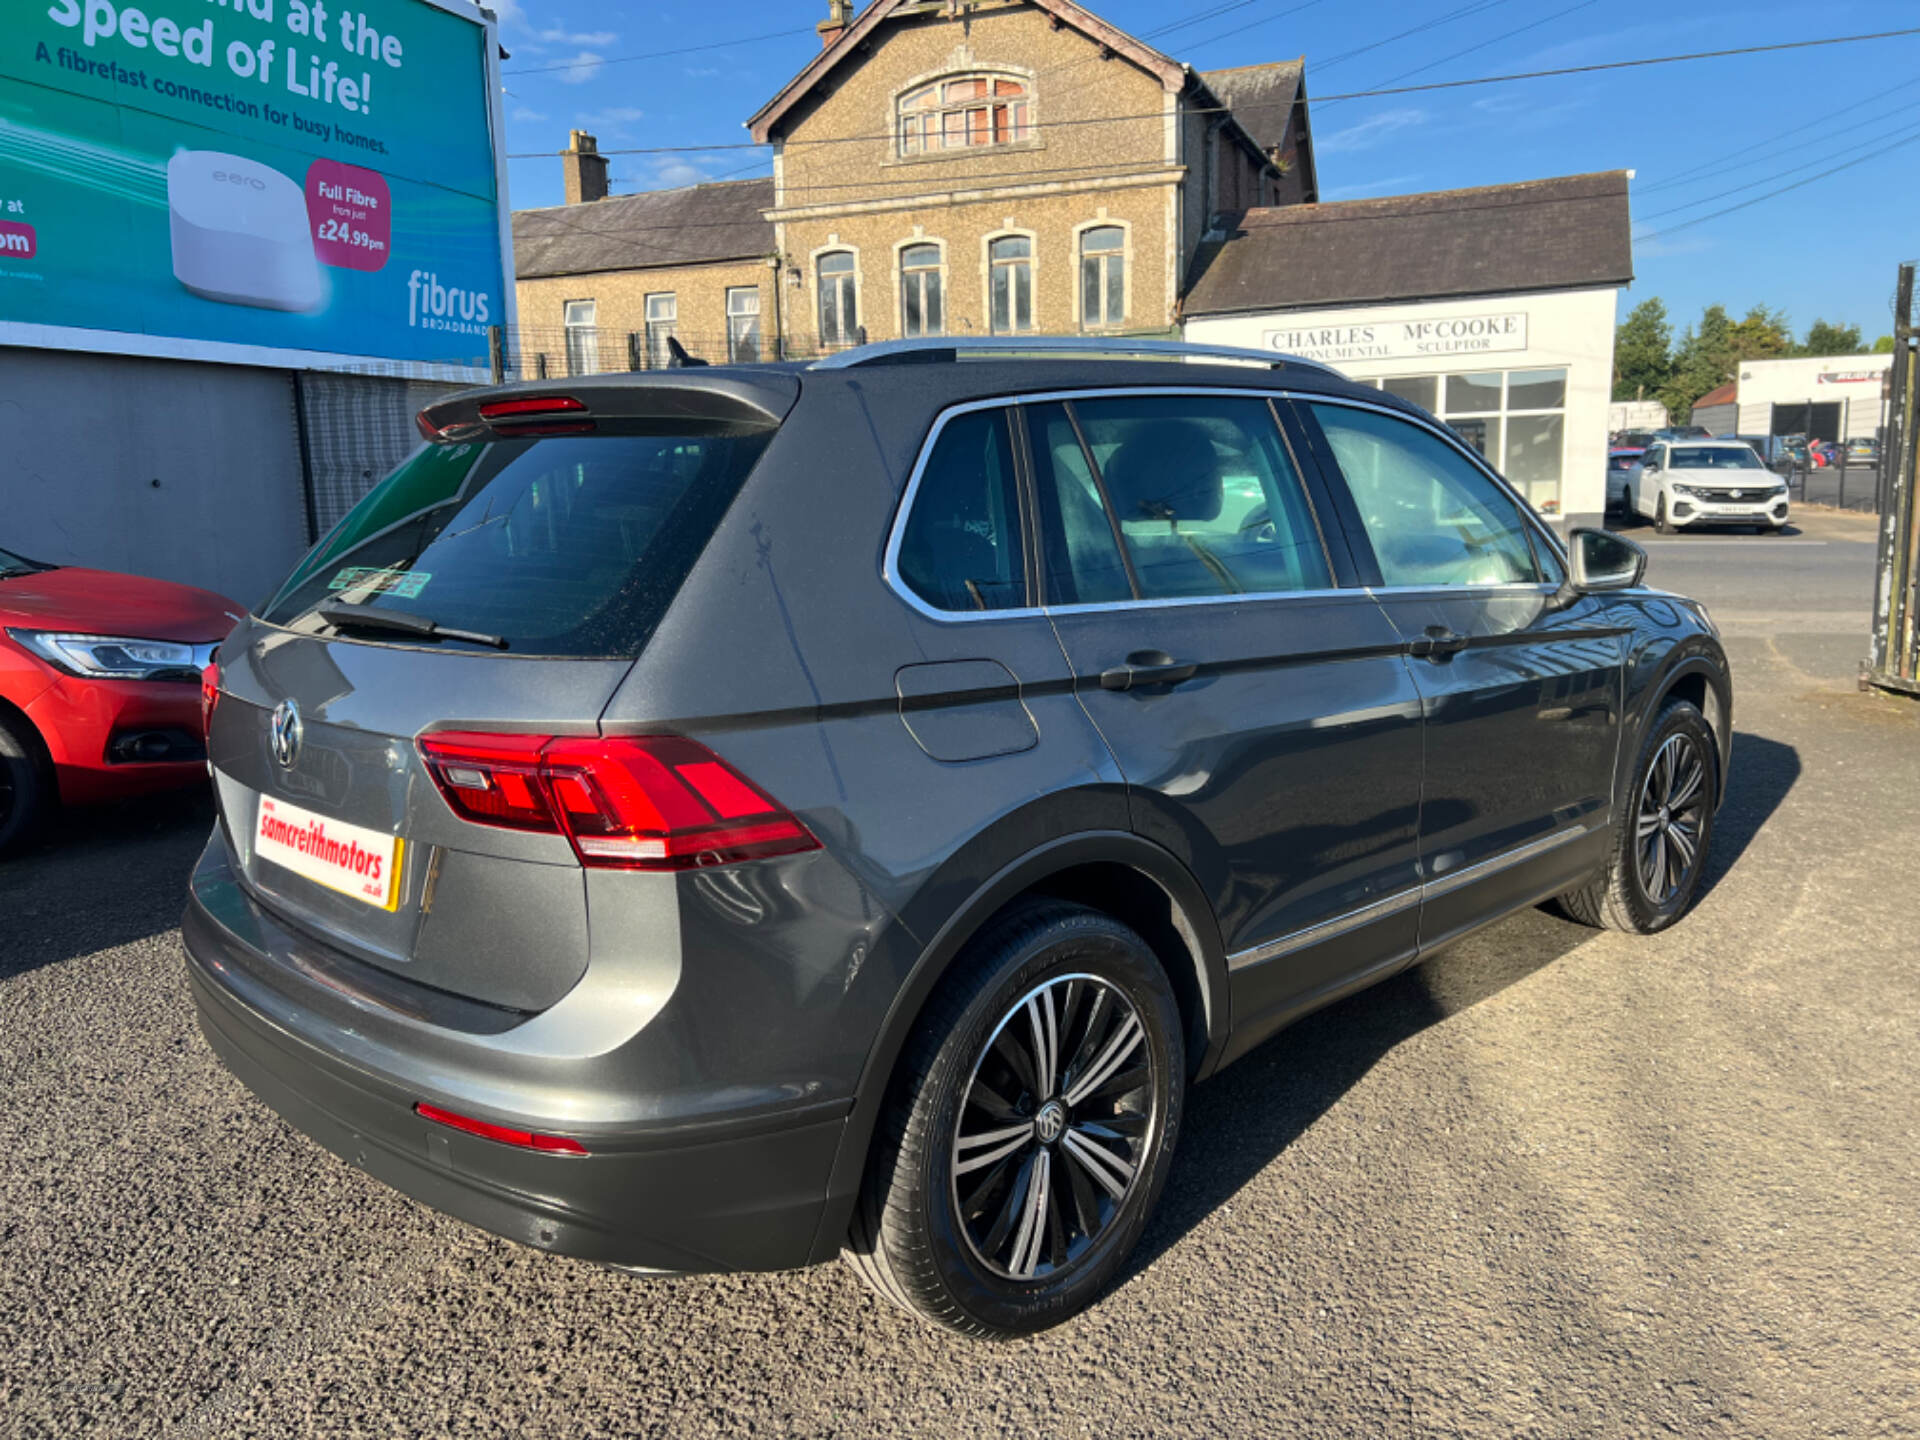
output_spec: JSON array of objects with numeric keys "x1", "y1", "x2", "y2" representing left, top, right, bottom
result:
[{"x1": 881, "y1": 385, "x2": 1567, "y2": 624}]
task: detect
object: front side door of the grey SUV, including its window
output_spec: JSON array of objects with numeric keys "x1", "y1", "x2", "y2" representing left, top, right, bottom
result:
[{"x1": 1294, "y1": 401, "x2": 1622, "y2": 950}]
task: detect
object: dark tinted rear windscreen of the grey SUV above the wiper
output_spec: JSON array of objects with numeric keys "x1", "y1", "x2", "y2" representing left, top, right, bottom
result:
[{"x1": 259, "y1": 422, "x2": 774, "y2": 659}]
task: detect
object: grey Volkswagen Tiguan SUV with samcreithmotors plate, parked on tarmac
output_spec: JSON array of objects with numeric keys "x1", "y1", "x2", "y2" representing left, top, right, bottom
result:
[{"x1": 184, "y1": 342, "x2": 1730, "y2": 1334}]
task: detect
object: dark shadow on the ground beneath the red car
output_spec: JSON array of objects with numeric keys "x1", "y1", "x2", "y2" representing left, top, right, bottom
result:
[{"x1": 0, "y1": 787, "x2": 213, "y2": 979}]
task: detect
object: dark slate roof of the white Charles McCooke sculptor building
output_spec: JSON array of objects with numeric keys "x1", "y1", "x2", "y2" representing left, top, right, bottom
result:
[{"x1": 1181, "y1": 171, "x2": 1634, "y2": 317}]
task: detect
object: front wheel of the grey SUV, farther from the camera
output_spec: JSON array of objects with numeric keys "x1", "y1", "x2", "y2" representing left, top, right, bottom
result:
[{"x1": 1557, "y1": 701, "x2": 1720, "y2": 935}]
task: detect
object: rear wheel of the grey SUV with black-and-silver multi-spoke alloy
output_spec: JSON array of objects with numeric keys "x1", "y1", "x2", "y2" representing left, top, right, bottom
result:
[{"x1": 847, "y1": 900, "x2": 1187, "y2": 1338}]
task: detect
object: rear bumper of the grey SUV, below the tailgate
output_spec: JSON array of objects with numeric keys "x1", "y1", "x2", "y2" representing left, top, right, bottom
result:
[{"x1": 182, "y1": 844, "x2": 847, "y2": 1271}]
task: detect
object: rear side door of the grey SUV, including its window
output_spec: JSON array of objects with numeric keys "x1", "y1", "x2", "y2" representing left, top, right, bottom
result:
[{"x1": 1023, "y1": 392, "x2": 1421, "y2": 1048}]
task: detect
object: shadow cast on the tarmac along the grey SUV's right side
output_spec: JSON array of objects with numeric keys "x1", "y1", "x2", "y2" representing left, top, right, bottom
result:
[{"x1": 1127, "y1": 732, "x2": 1801, "y2": 1279}]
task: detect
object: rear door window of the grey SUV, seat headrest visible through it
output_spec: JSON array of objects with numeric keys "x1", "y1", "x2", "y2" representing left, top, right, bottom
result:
[{"x1": 1031, "y1": 396, "x2": 1332, "y2": 603}]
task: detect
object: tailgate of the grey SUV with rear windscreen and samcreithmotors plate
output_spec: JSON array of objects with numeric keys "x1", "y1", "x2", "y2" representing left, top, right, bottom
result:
[{"x1": 209, "y1": 396, "x2": 794, "y2": 1012}]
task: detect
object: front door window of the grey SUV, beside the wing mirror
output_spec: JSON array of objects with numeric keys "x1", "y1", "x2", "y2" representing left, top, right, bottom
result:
[{"x1": 1311, "y1": 405, "x2": 1540, "y2": 586}]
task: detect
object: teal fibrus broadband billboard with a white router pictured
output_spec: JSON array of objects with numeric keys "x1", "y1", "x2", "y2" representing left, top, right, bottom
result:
[{"x1": 0, "y1": 0, "x2": 513, "y2": 378}]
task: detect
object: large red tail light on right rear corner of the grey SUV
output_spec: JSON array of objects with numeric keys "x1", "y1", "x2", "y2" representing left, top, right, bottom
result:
[{"x1": 420, "y1": 733, "x2": 820, "y2": 870}]
